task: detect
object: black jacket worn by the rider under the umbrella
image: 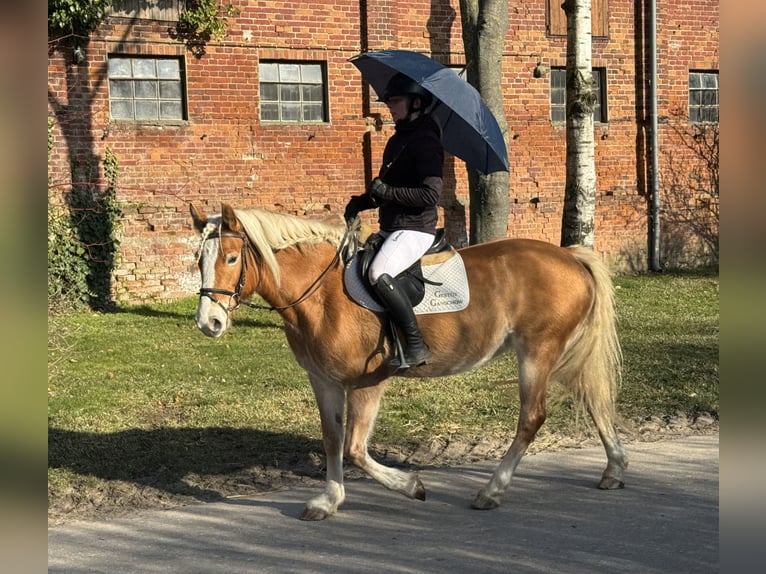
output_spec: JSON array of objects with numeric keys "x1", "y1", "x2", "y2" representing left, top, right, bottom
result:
[{"x1": 378, "y1": 115, "x2": 444, "y2": 234}]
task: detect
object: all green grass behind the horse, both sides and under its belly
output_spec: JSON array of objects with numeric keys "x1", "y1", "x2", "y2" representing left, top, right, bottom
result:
[{"x1": 48, "y1": 272, "x2": 719, "y2": 513}]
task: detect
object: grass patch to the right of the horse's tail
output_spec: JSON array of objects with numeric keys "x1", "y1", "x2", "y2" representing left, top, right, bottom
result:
[{"x1": 615, "y1": 273, "x2": 719, "y2": 420}]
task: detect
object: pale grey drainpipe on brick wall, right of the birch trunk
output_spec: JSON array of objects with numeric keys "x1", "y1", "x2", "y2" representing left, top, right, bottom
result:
[{"x1": 649, "y1": 0, "x2": 662, "y2": 272}]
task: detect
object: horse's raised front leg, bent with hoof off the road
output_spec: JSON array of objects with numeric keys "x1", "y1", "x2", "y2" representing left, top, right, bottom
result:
[{"x1": 345, "y1": 381, "x2": 426, "y2": 500}]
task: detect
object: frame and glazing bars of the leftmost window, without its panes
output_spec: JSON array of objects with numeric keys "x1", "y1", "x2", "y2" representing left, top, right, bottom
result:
[{"x1": 107, "y1": 53, "x2": 189, "y2": 124}]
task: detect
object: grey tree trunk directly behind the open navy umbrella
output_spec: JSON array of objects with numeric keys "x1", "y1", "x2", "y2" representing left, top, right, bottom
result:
[{"x1": 460, "y1": 0, "x2": 510, "y2": 244}]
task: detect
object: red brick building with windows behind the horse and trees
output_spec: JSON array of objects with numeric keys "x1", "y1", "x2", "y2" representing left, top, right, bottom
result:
[{"x1": 48, "y1": 0, "x2": 719, "y2": 302}]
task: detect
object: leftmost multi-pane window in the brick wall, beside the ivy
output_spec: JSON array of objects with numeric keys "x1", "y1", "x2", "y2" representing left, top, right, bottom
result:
[{"x1": 109, "y1": 56, "x2": 186, "y2": 121}]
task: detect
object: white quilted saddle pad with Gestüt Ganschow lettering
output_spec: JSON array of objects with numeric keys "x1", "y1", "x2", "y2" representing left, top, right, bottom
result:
[{"x1": 343, "y1": 253, "x2": 470, "y2": 315}]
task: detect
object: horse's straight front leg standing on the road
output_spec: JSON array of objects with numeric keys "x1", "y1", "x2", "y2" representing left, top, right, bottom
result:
[{"x1": 300, "y1": 375, "x2": 346, "y2": 520}]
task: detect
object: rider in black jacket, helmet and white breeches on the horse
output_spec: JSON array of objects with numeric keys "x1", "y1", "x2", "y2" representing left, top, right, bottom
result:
[{"x1": 344, "y1": 74, "x2": 444, "y2": 368}]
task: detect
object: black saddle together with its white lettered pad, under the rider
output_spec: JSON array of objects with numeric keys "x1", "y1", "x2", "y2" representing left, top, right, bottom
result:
[{"x1": 343, "y1": 228, "x2": 469, "y2": 315}]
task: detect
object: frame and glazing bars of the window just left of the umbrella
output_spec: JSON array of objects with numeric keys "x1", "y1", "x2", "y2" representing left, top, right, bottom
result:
[{"x1": 258, "y1": 59, "x2": 330, "y2": 126}]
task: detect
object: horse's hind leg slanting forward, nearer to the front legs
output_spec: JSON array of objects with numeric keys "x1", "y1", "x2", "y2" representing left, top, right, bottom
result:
[{"x1": 471, "y1": 359, "x2": 550, "y2": 510}]
